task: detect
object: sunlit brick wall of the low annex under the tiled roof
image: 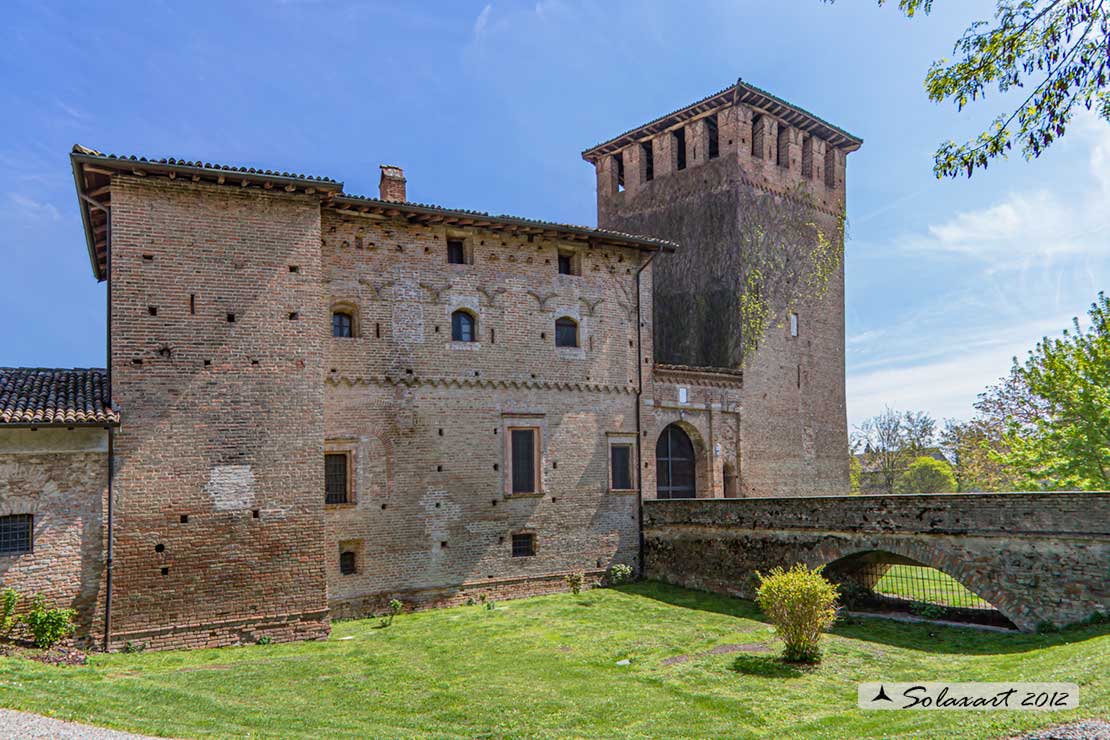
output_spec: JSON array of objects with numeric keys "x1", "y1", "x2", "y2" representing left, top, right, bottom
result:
[{"x1": 0, "y1": 428, "x2": 108, "y2": 640}]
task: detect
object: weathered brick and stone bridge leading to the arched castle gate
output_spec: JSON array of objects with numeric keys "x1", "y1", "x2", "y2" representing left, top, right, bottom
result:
[{"x1": 644, "y1": 493, "x2": 1110, "y2": 631}]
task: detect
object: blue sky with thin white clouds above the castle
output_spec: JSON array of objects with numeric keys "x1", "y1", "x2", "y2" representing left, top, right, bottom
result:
[{"x1": 0, "y1": 0, "x2": 1110, "y2": 425}]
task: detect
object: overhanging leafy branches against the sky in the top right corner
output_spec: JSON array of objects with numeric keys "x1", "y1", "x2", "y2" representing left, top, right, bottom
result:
[{"x1": 826, "y1": 0, "x2": 1110, "y2": 178}]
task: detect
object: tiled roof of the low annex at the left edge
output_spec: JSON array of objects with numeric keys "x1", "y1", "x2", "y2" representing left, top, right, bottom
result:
[{"x1": 0, "y1": 367, "x2": 120, "y2": 426}]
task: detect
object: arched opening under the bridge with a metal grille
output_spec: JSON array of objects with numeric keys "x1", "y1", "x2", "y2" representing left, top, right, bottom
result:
[{"x1": 824, "y1": 550, "x2": 1017, "y2": 629}]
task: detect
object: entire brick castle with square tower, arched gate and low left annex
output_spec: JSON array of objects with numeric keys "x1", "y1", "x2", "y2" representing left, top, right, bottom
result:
[{"x1": 0, "y1": 81, "x2": 861, "y2": 648}]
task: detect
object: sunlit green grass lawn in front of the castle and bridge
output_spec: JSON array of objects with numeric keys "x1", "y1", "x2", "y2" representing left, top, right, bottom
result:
[{"x1": 0, "y1": 582, "x2": 1110, "y2": 738}]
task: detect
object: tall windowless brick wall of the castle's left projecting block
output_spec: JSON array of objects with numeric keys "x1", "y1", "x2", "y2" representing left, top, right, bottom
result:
[{"x1": 103, "y1": 175, "x2": 327, "y2": 647}]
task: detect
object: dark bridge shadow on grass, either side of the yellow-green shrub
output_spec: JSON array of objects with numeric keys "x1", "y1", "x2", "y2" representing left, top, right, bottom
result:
[{"x1": 617, "y1": 580, "x2": 1110, "y2": 656}]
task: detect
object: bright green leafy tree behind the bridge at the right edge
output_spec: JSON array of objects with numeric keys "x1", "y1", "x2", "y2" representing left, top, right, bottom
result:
[{"x1": 998, "y1": 293, "x2": 1110, "y2": 490}]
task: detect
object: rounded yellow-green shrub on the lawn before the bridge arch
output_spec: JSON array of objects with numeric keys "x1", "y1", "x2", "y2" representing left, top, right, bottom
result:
[{"x1": 756, "y1": 564, "x2": 838, "y2": 662}]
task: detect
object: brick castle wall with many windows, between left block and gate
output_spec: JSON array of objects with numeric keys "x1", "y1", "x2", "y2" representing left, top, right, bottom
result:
[{"x1": 319, "y1": 209, "x2": 650, "y2": 616}]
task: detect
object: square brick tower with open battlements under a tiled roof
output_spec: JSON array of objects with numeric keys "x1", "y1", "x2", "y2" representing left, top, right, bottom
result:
[{"x1": 583, "y1": 81, "x2": 862, "y2": 496}]
